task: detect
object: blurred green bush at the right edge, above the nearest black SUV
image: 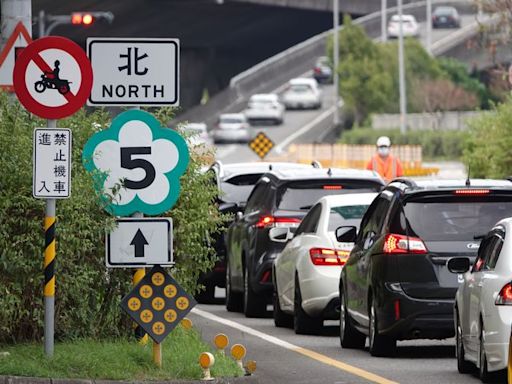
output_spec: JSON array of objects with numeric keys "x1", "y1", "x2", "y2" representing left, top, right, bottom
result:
[{"x1": 464, "y1": 97, "x2": 512, "y2": 178}]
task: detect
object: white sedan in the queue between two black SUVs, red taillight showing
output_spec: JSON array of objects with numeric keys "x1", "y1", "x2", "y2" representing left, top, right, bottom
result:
[{"x1": 270, "y1": 190, "x2": 377, "y2": 334}]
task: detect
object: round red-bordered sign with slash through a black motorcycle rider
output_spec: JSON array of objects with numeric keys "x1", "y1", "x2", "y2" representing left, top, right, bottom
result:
[{"x1": 13, "y1": 36, "x2": 92, "y2": 119}]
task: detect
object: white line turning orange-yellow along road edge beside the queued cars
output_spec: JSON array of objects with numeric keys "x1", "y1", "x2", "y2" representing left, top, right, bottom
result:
[{"x1": 192, "y1": 308, "x2": 398, "y2": 384}]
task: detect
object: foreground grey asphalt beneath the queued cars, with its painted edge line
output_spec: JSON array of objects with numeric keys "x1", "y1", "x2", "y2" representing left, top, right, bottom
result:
[{"x1": 190, "y1": 296, "x2": 506, "y2": 384}]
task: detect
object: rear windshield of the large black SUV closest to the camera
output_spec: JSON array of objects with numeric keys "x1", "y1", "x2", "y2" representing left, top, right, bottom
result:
[{"x1": 390, "y1": 196, "x2": 512, "y2": 241}]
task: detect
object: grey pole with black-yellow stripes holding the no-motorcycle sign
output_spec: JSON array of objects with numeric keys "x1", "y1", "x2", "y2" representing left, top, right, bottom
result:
[{"x1": 44, "y1": 120, "x2": 57, "y2": 357}]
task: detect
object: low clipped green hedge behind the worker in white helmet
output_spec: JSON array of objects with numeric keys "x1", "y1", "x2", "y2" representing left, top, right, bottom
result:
[{"x1": 340, "y1": 128, "x2": 467, "y2": 160}]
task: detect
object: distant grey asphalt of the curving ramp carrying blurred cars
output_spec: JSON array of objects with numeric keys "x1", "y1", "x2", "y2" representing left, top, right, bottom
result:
[{"x1": 216, "y1": 15, "x2": 474, "y2": 163}]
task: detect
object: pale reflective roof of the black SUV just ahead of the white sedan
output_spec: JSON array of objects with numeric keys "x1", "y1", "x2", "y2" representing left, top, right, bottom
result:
[{"x1": 265, "y1": 167, "x2": 383, "y2": 183}]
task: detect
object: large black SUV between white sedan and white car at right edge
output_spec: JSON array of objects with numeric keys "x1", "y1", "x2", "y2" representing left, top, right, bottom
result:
[{"x1": 336, "y1": 179, "x2": 512, "y2": 356}]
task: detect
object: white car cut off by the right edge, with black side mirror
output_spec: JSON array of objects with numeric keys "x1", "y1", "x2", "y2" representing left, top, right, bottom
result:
[{"x1": 448, "y1": 218, "x2": 512, "y2": 382}]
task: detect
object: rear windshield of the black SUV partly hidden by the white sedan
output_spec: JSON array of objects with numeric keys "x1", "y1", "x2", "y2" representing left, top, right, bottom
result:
[{"x1": 277, "y1": 180, "x2": 382, "y2": 211}]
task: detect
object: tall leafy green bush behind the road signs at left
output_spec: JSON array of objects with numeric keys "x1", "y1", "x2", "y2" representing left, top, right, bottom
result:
[{"x1": 0, "y1": 93, "x2": 222, "y2": 343}]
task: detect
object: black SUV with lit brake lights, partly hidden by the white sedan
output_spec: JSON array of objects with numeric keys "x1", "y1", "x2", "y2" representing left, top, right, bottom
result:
[{"x1": 226, "y1": 168, "x2": 384, "y2": 317}]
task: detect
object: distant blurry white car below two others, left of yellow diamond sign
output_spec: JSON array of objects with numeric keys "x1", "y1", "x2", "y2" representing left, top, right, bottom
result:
[{"x1": 212, "y1": 113, "x2": 251, "y2": 143}]
